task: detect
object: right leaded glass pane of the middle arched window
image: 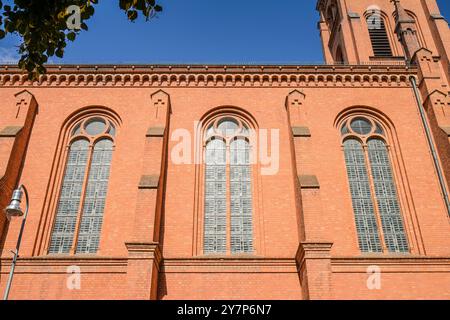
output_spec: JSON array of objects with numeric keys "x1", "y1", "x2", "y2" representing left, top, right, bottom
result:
[{"x1": 230, "y1": 139, "x2": 253, "y2": 253}]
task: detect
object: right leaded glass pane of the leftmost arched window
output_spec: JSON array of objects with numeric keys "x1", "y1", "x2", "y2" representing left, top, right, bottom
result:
[{"x1": 76, "y1": 139, "x2": 113, "y2": 253}]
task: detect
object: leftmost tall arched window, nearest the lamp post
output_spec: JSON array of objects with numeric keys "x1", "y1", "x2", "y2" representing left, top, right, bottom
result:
[{"x1": 48, "y1": 116, "x2": 115, "y2": 254}]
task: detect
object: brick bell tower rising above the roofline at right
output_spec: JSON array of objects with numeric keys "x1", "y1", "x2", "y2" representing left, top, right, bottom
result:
[{"x1": 317, "y1": 0, "x2": 450, "y2": 68}]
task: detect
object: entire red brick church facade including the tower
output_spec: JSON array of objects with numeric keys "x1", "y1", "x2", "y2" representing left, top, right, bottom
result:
[{"x1": 0, "y1": 0, "x2": 450, "y2": 299}]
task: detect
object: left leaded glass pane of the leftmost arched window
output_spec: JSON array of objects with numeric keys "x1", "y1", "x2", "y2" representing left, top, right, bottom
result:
[{"x1": 49, "y1": 140, "x2": 89, "y2": 253}]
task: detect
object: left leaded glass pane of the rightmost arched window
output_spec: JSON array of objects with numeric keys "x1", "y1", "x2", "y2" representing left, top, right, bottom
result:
[{"x1": 344, "y1": 139, "x2": 382, "y2": 252}]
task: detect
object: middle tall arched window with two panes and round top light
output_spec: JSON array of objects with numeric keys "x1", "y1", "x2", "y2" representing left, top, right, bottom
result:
[{"x1": 203, "y1": 116, "x2": 253, "y2": 254}]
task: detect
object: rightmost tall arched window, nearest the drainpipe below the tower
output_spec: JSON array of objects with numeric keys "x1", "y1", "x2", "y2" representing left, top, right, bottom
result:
[{"x1": 341, "y1": 117, "x2": 409, "y2": 252}]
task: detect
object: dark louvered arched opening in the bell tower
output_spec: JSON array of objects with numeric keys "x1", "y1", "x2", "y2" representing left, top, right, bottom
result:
[{"x1": 367, "y1": 15, "x2": 392, "y2": 57}]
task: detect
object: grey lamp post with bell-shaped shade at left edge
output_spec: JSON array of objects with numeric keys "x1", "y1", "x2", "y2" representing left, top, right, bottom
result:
[{"x1": 3, "y1": 185, "x2": 29, "y2": 300}]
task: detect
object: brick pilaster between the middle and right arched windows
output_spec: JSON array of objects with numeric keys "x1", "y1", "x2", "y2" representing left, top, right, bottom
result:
[{"x1": 286, "y1": 90, "x2": 332, "y2": 299}]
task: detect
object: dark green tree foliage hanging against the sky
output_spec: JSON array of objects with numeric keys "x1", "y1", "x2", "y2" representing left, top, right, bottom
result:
[{"x1": 0, "y1": 0, "x2": 162, "y2": 79}]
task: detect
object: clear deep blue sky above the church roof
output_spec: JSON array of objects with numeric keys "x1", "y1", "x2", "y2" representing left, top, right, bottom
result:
[{"x1": 0, "y1": 0, "x2": 450, "y2": 64}]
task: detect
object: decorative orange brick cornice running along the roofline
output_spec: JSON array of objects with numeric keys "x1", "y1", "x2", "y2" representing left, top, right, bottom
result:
[{"x1": 0, "y1": 62, "x2": 417, "y2": 88}]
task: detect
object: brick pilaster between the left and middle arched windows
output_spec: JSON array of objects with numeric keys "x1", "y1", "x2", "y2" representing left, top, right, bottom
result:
[{"x1": 126, "y1": 90, "x2": 171, "y2": 299}]
